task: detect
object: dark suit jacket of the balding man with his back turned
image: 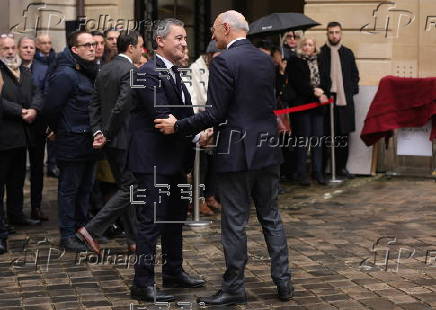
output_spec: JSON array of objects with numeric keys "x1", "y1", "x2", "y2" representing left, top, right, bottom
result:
[{"x1": 176, "y1": 39, "x2": 282, "y2": 172}]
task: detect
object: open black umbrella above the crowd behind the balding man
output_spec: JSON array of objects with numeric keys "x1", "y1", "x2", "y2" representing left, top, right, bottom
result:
[{"x1": 248, "y1": 13, "x2": 320, "y2": 36}]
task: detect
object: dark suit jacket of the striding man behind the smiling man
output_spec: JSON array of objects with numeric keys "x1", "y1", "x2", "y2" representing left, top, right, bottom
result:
[{"x1": 88, "y1": 56, "x2": 136, "y2": 150}]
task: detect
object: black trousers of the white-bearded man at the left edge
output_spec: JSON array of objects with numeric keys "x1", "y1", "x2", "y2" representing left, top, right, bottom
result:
[{"x1": 0, "y1": 147, "x2": 26, "y2": 222}]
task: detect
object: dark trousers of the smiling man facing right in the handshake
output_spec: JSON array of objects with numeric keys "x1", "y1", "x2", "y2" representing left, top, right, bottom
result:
[{"x1": 133, "y1": 174, "x2": 189, "y2": 287}]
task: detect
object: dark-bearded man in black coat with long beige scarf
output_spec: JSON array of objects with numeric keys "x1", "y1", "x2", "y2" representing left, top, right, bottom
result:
[{"x1": 319, "y1": 22, "x2": 360, "y2": 178}]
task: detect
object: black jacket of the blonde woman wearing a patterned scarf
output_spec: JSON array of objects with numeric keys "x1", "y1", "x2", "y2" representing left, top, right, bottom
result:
[{"x1": 287, "y1": 57, "x2": 327, "y2": 112}]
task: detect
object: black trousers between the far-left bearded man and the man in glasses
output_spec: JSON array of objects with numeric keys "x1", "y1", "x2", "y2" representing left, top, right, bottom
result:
[{"x1": 29, "y1": 135, "x2": 45, "y2": 210}]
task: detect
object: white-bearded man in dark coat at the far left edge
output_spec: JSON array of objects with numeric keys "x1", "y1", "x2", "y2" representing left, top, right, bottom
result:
[{"x1": 0, "y1": 35, "x2": 41, "y2": 225}]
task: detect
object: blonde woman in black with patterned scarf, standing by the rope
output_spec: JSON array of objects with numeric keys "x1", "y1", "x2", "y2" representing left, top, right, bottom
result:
[{"x1": 287, "y1": 38, "x2": 328, "y2": 186}]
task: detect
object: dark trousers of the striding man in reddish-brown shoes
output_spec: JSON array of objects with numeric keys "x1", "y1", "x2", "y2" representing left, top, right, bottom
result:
[{"x1": 85, "y1": 148, "x2": 137, "y2": 243}]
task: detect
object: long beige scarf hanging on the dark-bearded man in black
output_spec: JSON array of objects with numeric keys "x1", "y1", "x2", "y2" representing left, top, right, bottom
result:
[{"x1": 326, "y1": 41, "x2": 347, "y2": 106}]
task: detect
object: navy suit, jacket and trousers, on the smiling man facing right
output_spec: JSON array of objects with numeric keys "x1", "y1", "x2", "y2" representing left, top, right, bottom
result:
[{"x1": 128, "y1": 57, "x2": 194, "y2": 287}]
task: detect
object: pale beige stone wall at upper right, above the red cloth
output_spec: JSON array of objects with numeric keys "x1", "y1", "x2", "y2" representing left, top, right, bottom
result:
[{"x1": 305, "y1": 0, "x2": 436, "y2": 85}]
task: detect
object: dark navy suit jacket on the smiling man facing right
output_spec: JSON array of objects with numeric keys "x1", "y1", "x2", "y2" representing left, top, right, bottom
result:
[{"x1": 128, "y1": 57, "x2": 194, "y2": 175}]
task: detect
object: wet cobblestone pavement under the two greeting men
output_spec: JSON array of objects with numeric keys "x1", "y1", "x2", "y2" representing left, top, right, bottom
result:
[{"x1": 0, "y1": 177, "x2": 436, "y2": 310}]
